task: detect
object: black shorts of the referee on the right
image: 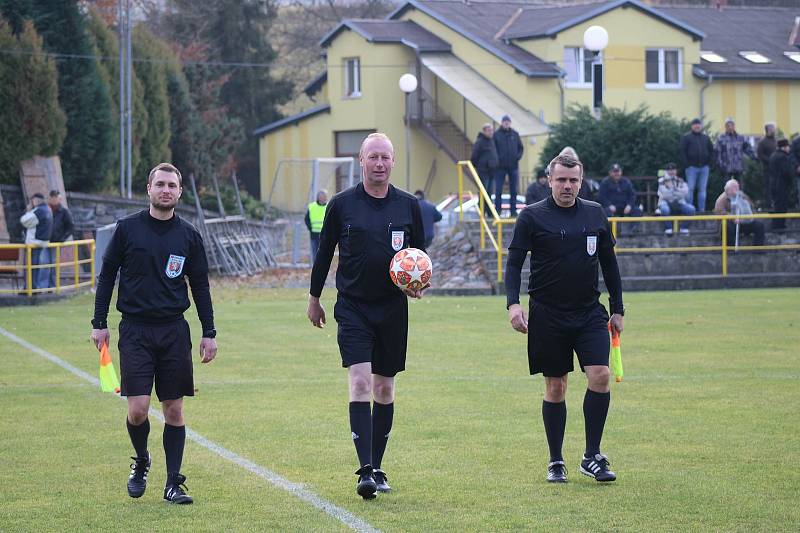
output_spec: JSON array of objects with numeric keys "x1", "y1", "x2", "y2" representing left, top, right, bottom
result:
[{"x1": 528, "y1": 300, "x2": 611, "y2": 377}]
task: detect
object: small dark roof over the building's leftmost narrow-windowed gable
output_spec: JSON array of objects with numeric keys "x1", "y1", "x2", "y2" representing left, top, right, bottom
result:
[{"x1": 320, "y1": 19, "x2": 450, "y2": 52}]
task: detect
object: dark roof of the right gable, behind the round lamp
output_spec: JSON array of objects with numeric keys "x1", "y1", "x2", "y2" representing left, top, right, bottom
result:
[{"x1": 501, "y1": 0, "x2": 705, "y2": 40}]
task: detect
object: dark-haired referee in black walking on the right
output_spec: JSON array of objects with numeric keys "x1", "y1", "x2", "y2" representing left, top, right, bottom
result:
[{"x1": 506, "y1": 147, "x2": 624, "y2": 483}]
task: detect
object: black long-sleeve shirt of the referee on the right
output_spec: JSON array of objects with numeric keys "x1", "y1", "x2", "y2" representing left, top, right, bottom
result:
[{"x1": 506, "y1": 196, "x2": 623, "y2": 314}]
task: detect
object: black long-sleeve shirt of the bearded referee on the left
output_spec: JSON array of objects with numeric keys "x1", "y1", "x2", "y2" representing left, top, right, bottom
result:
[{"x1": 92, "y1": 210, "x2": 214, "y2": 332}]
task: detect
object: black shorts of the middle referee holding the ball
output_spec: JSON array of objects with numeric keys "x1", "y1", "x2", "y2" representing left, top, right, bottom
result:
[{"x1": 333, "y1": 293, "x2": 408, "y2": 377}]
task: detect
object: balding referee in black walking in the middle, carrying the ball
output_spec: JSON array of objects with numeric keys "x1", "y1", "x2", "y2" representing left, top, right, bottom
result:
[{"x1": 308, "y1": 133, "x2": 425, "y2": 499}]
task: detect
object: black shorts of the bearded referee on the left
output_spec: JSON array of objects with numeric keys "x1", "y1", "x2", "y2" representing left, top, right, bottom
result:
[{"x1": 119, "y1": 319, "x2": 194, "y2": 402}]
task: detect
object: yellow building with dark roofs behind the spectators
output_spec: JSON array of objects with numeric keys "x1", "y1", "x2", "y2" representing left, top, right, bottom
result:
[{"x1": 254, "y1": 0, "x2": 800, "y2": 208}]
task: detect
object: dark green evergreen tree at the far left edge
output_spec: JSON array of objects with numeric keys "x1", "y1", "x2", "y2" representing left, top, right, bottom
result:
[{"x1": 0, "y1": 18, "x2": 66, "y2": 183}]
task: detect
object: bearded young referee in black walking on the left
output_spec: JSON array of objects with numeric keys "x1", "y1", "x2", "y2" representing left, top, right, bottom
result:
[{"x1": 92, "y1": 163, "x2": 217, "y2": 504}]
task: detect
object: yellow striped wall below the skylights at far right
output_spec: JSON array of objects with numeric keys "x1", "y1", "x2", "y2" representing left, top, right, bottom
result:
[{"x1": 705, "y1": 80, "x2": 800, "y2": 137}]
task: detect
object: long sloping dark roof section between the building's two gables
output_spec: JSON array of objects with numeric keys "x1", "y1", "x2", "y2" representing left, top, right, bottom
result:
[{"x1": 388, "y1": 0, "x2": 561, "y2": 78}]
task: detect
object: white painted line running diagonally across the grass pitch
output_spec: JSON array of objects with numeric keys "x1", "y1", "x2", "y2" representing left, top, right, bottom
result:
[{"x1": 0, "y1": 327, "x2": 380, "y2": 533}]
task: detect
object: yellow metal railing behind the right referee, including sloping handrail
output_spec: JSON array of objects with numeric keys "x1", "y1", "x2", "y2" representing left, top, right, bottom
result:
[{"x1": 456, "y1": 161, "x2": 800, "y2": 282}]
